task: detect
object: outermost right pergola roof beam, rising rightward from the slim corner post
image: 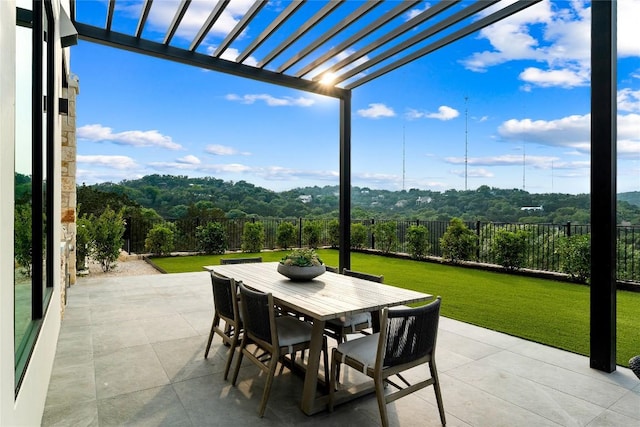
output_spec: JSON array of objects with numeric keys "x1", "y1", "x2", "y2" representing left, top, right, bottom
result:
[{"x1": 344, "y1": 0, "x2": 541, "y2": 89}]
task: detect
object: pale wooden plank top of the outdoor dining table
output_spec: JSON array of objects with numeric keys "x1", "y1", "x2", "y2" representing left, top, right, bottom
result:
[{"x1": 204, "y1": 262, "x2": 433, "y2": 321}]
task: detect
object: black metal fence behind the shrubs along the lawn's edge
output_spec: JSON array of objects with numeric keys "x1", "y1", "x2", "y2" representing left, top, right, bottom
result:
[{"x1": 125, "y1": 218, "x2": 640, "y2": 282}]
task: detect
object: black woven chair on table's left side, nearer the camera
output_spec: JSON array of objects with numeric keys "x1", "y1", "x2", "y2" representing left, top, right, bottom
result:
[{"x1": 231, "y1": 282, "x2": 329, "y2": 417}]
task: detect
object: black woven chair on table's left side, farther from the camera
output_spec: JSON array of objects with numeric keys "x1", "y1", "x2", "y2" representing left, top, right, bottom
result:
[{"x1": 204, "y1": 272, "x2": 242, "y2": 380}]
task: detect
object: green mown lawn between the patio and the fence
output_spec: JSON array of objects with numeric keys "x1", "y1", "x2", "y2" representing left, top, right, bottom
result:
[{"x1": 153, "y1": 249, "x2": 640, "y2": 366}]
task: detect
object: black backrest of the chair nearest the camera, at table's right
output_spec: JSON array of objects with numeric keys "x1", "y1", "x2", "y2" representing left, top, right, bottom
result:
[{"x1": 378, "y1": 297, "x2": 441, "y2": 366}]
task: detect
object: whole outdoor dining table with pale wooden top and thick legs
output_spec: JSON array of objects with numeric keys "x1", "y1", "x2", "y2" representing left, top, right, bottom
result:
[{"x1": 204, "y1": 262, "x2": 433, "y2": 415}]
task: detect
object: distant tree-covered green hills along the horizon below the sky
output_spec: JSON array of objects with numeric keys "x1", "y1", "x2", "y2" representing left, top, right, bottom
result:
[{"x1": 78, "y1": 175, "x2": 640, "y2": 224}]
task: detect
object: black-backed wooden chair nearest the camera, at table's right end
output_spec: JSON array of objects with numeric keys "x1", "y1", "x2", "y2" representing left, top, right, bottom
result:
[{"x1": 329, "y1": 297, "x2": 446, "y2": 426}]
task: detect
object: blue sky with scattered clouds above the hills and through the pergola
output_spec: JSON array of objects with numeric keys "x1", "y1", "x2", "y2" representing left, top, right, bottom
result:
[{"x1": 71, "y1": 0, "x2": 640, "y2": 194}]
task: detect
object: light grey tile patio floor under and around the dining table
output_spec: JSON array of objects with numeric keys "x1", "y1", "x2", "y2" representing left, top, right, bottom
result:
[{"x1": 42, "y1": 272, "x2": 640, "y2": 427}]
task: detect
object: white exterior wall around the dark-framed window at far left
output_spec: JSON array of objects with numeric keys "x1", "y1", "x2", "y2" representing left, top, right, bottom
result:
[{"x1": 0, "y1": 0, "x2": 62, "y2": 426}]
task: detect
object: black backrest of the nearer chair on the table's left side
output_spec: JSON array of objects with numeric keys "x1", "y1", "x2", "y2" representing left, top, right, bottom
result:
[{"x1": 239, "y1": 282, "x2": 277, "y2": 345}]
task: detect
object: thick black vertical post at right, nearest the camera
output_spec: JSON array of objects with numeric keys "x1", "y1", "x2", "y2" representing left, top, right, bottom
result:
[{"x1": 590, "y1": 0, "x2": 617, "y2": 372}]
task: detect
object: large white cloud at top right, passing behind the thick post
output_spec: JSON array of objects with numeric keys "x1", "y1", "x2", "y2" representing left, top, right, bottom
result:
[{"x1": 462, "y1": 0, "x2": 640, "y2": 91}]
